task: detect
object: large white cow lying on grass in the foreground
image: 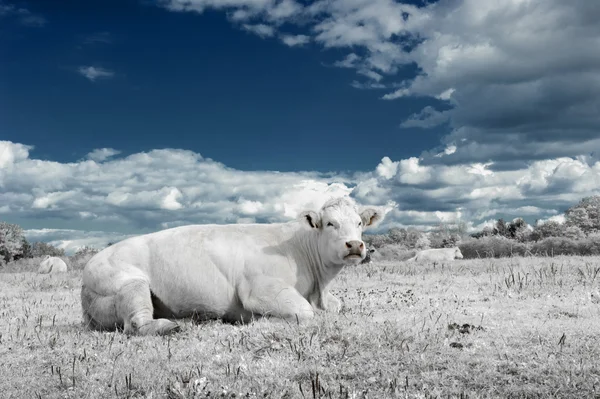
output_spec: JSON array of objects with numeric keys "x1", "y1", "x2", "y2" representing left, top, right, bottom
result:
[{"x1": 81, "y1": 198, "x2": 381, "y2": 335}]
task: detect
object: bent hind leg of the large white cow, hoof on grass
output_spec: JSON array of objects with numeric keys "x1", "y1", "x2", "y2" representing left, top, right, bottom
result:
[{"x1": 116, "y1": 279, "x2": 179, "y2": 335}]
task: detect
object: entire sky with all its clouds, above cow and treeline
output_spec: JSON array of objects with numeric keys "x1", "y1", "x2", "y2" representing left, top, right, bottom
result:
[{"x1": 0, "y1": 0, "x2": 600, "y2": 253}]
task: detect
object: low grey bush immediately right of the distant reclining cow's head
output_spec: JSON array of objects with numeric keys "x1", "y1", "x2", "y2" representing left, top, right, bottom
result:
[{"x1": 458, "y1": 236, "x2": 529, "y2": 259}]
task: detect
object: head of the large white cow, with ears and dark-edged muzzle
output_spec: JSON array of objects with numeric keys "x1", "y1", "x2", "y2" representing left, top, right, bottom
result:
[{"x1": 301, "y1": 197, "x2": 382, "y2": 265}]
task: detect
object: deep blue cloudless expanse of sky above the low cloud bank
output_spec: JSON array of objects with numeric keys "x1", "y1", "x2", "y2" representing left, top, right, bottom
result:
[{"x1": 0, "y1": 0, "x2": 443, "y2": 172}]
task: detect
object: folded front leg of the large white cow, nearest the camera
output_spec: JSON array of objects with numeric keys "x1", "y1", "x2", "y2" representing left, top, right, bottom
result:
[{"x1": 237, "y1": 275, "x2": 314, "y2": 321}]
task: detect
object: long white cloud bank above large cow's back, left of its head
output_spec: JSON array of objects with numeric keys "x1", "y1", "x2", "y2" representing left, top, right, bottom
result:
[{"x1": 0, "y1": 142, "x2": 385, "y2": 236}]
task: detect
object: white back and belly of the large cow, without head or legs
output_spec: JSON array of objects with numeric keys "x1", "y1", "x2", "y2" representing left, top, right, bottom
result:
[{"x1": 83, "y1": 223, "x2": 296, "y2": 318}]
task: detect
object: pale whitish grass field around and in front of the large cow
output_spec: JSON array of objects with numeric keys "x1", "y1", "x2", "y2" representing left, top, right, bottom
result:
[{"x1": 0, "y1": 257, "x2": 600, "y2": 398}]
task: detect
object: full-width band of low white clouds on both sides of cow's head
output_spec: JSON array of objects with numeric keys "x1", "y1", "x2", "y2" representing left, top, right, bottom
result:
[{"x1": 7, "y1": 141, "x2": 600, "y2": 248}]
